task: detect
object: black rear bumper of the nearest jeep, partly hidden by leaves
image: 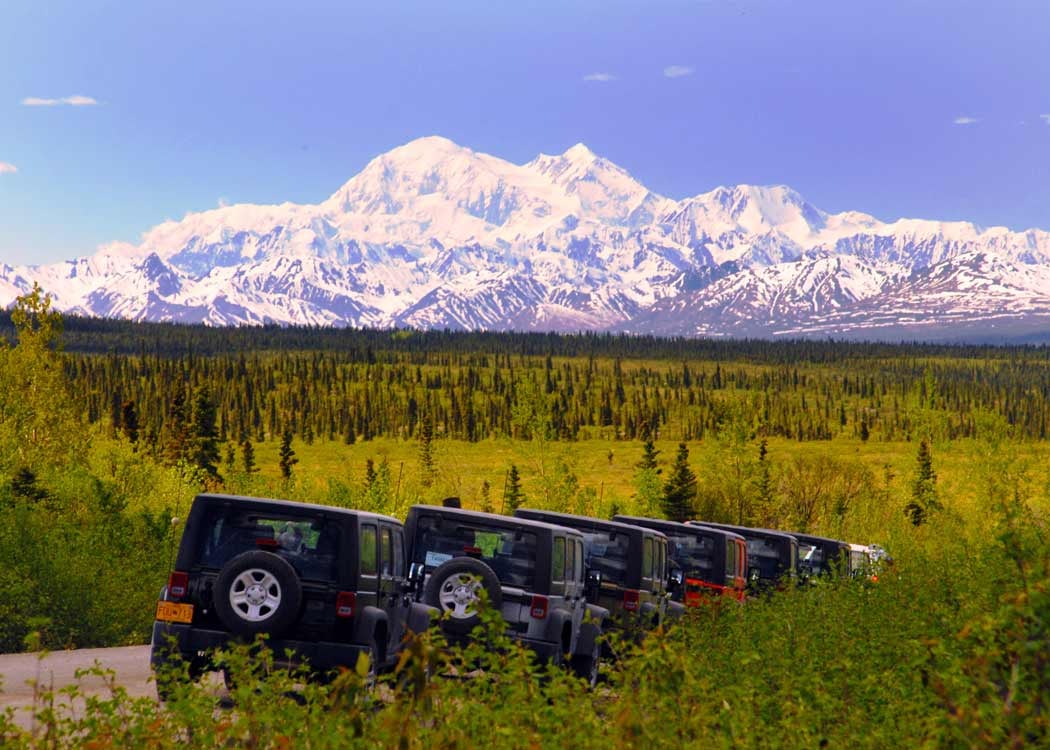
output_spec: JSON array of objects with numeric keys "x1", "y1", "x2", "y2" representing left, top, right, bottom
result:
[{"x1": 149, "y1": 622, "x2": 369, "y2": 671}]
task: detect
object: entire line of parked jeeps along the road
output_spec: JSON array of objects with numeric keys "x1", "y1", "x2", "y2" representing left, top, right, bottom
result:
[{"x1": 150, "y1": 494, "x2": 885, "y2": 700}]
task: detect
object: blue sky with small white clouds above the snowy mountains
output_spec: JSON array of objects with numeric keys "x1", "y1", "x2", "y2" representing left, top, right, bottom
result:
[{"x1": 0, "y1": 0, "x2": 1050, "y2": 264}]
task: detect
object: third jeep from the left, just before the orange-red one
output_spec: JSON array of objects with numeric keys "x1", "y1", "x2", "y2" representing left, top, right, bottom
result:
[{"x1": 515, "y1": 507, "x2": 685, "y2": 628}]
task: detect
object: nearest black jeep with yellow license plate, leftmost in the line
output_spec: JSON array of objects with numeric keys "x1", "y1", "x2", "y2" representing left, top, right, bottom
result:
[{"x1": 150, "y1": 495, "x2": 436, "y2": 697}]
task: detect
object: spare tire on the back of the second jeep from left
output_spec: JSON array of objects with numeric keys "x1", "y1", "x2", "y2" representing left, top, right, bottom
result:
[{"x1": 423, "y1": 558, "x2": 503, "y2": 636}]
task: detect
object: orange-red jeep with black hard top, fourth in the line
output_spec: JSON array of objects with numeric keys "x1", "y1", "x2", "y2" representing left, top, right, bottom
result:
[{"x1": 612, "y1": 516, "x2": 748, "y2": 607}]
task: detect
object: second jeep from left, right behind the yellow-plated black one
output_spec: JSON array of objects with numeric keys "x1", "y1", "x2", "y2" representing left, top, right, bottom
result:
[{"x1": 405, "y1": 505, "x2": 608, "y2": 684}]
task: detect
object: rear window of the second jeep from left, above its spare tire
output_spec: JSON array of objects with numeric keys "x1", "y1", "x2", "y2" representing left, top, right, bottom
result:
[{"x1": 413, "y1": 516, "x2": 537, "y2": 588}]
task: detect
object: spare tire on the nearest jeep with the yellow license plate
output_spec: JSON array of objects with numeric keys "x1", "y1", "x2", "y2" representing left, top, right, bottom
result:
[{"x1": 212, "y1": 550, "x2": 302, "y2": 637}]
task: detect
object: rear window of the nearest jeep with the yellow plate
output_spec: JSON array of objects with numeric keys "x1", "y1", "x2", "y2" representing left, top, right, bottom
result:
[{"x1": 196, "y1": 507, "x2": 339, "y2": 580}]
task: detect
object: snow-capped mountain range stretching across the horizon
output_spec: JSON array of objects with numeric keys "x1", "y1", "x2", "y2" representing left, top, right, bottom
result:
[{"x1": 0, "y1": 137, "x2": 1050, "y2": 337}]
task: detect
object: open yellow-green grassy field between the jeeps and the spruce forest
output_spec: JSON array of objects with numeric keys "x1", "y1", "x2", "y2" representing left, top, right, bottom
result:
[{"x1": 245, "y1": 438, "x2": 1050, "y2": 531}]
